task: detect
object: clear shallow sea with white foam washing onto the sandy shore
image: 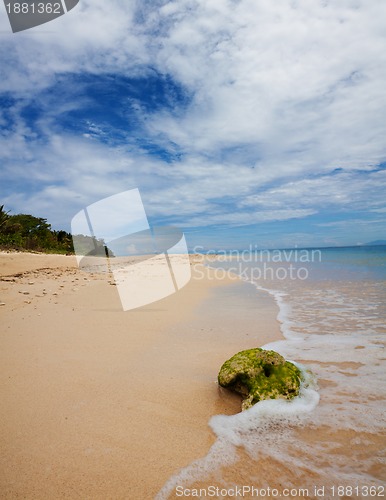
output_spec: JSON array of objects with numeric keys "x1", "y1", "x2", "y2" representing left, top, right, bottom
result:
[{"x1": 158, "y1": 246, "x2": 386, "y2": 499}]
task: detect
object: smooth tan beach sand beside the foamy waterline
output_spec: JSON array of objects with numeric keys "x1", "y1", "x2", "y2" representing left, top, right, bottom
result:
[{"x1": 0, "y1": 253, "x2": 280, "y2": 500}]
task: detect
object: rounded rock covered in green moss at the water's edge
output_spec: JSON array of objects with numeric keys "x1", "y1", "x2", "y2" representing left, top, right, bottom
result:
[{"x1": 218, "y1": 348, "x2": 302, "y2": 410}]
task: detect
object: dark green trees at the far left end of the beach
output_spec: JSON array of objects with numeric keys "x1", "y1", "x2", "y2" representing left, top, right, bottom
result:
[{"x1": 0, "y1": 205, "x2": 74, "y2": 253}]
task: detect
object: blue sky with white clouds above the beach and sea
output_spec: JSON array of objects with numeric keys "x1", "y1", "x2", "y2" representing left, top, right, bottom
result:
[{"x1": 0, "y1": 0, "x2": 386, "y2": 249}]
